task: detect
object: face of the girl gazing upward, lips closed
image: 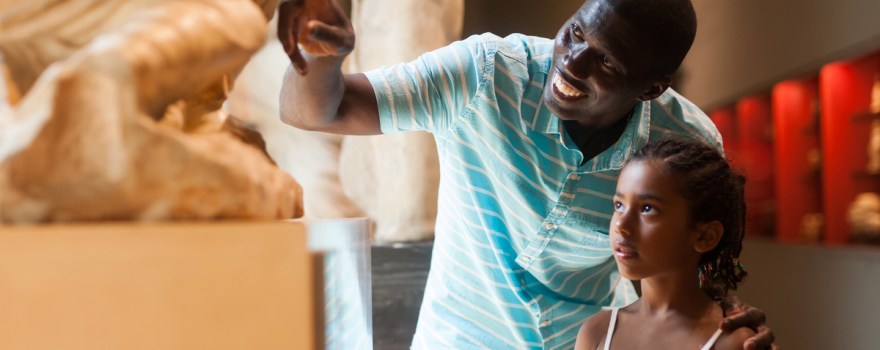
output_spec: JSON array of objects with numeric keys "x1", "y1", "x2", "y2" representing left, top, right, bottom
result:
[{"x1": 608, "y1": 160, "x2": 700, "y2": 280}]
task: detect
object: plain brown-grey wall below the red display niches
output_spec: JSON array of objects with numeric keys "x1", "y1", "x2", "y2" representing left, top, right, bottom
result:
[{"x1": 736, "y1": 239, "x2": 880, "y2": 350}]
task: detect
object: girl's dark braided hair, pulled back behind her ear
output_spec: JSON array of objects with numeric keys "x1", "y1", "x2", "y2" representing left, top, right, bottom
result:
[{"x1": 631, "y1": 139, "x2": 747, "y2": 299}]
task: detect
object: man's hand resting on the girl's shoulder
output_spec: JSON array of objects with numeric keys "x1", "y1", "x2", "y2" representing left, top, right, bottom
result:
[{"x1": 721, "y1": 296, "x2": 778, "y2": 350}]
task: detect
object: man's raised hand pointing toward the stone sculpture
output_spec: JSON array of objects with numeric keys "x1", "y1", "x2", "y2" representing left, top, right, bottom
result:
[{"x1": 278, "y1": 0, "x2": 354, "y2": 75}]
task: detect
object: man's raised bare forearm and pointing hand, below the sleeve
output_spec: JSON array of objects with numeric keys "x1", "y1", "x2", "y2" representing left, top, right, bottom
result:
[{"x1": 278, "y1": 0, "x2": 381, "y2": 135}]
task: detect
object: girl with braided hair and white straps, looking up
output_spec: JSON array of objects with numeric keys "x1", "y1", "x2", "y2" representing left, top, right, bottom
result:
[{"x1": 575, "y1": 140, "x2": 754, "y2": 350}]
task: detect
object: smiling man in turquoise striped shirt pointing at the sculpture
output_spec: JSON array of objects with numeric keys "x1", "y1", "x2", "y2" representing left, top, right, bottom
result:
[{"x1": 279, "y1": 0, "x2": 773, "y2": 349}]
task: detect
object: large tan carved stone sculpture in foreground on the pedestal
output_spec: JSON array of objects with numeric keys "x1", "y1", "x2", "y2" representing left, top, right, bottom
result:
[{"x1": 0, "y1": 0, "x2": 302, "y2": 222}]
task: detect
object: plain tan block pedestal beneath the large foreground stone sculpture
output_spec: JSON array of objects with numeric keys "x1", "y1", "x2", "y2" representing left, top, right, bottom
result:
[{"x1": 0, "y1": 220, "x2": 370, "y2": 350}]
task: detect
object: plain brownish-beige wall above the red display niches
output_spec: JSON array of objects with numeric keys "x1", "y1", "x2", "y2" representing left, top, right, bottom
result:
[{"x1": 679, "y1": 0, "x2": 880, "y2": 110}]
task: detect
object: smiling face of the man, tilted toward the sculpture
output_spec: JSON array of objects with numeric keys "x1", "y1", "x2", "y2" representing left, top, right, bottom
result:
[{"x1": 543, "y1": 0, "x2": 656, "y2": 128}]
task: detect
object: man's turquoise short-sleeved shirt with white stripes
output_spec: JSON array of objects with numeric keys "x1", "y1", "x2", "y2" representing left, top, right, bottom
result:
[{"x1": 367, "y1": 34, "x2": 721, "y2": 349}]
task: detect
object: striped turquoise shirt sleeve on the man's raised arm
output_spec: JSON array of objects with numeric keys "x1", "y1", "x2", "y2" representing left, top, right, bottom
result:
[{"x1": 365, "y1": 36, "x2": 493, "y2": 134}]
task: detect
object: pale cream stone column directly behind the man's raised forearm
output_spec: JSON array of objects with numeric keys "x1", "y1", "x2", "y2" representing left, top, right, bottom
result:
[{"x1": 340, "y1": 0, "x2": 464, "y2": 241}]
